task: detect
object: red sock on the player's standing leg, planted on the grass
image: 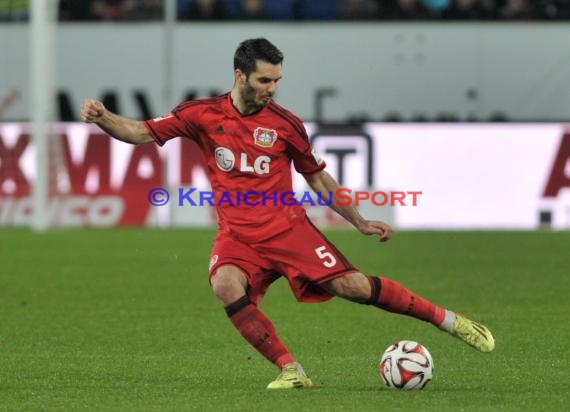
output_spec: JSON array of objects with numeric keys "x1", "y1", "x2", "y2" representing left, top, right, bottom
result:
[{"x1": 225, "y1": 296, "x2": 295, "y2": 368}]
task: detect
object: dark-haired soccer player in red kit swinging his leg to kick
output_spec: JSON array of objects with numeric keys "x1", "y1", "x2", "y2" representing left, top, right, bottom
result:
[{"x1": 81, "y1": 38, "x2": 495, "y2": 389}]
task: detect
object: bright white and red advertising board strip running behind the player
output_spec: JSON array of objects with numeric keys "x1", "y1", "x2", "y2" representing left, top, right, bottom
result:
[{"x1": 0, "y1": 123, "x2": 570, "y2": 229}]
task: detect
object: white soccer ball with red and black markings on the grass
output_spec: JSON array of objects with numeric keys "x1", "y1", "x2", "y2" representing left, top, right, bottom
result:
[{"x1": 380, "y1": 340, "x2": 433, "y2": 390}]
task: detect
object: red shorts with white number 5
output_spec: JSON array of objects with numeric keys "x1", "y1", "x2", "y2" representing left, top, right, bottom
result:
[{"x1": 210, "y1": 218, "x2": 358, "y2": 304}]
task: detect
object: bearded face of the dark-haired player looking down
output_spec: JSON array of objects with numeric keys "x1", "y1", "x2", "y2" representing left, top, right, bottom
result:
[{"x1": 236, "y1": 60, "x2": 282, "y2": 109}]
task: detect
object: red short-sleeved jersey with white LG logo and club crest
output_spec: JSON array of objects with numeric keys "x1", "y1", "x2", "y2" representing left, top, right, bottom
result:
[{"x1": 145, "y1": 93, "x2": 325, "y2": 242}]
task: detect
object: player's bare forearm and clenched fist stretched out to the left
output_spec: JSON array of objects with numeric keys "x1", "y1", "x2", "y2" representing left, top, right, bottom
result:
[{"x1": 81, "y1": 99, "x2": 153, "y2": 144}]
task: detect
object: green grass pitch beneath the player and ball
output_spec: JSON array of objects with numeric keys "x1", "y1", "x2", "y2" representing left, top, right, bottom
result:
[{"x1": 0, "y1": 229, "x2": 570, "y2": 412}]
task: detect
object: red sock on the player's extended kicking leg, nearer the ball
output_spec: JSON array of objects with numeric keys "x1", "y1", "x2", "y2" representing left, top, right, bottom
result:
[{"x1": 368, "y1": 276, "x2": 445, "y2": 326}]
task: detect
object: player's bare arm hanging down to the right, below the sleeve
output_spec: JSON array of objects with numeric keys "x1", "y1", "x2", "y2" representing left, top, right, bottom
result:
[{"x1": 303, "y1": 170, "x2": 393, "y2": 242}]
